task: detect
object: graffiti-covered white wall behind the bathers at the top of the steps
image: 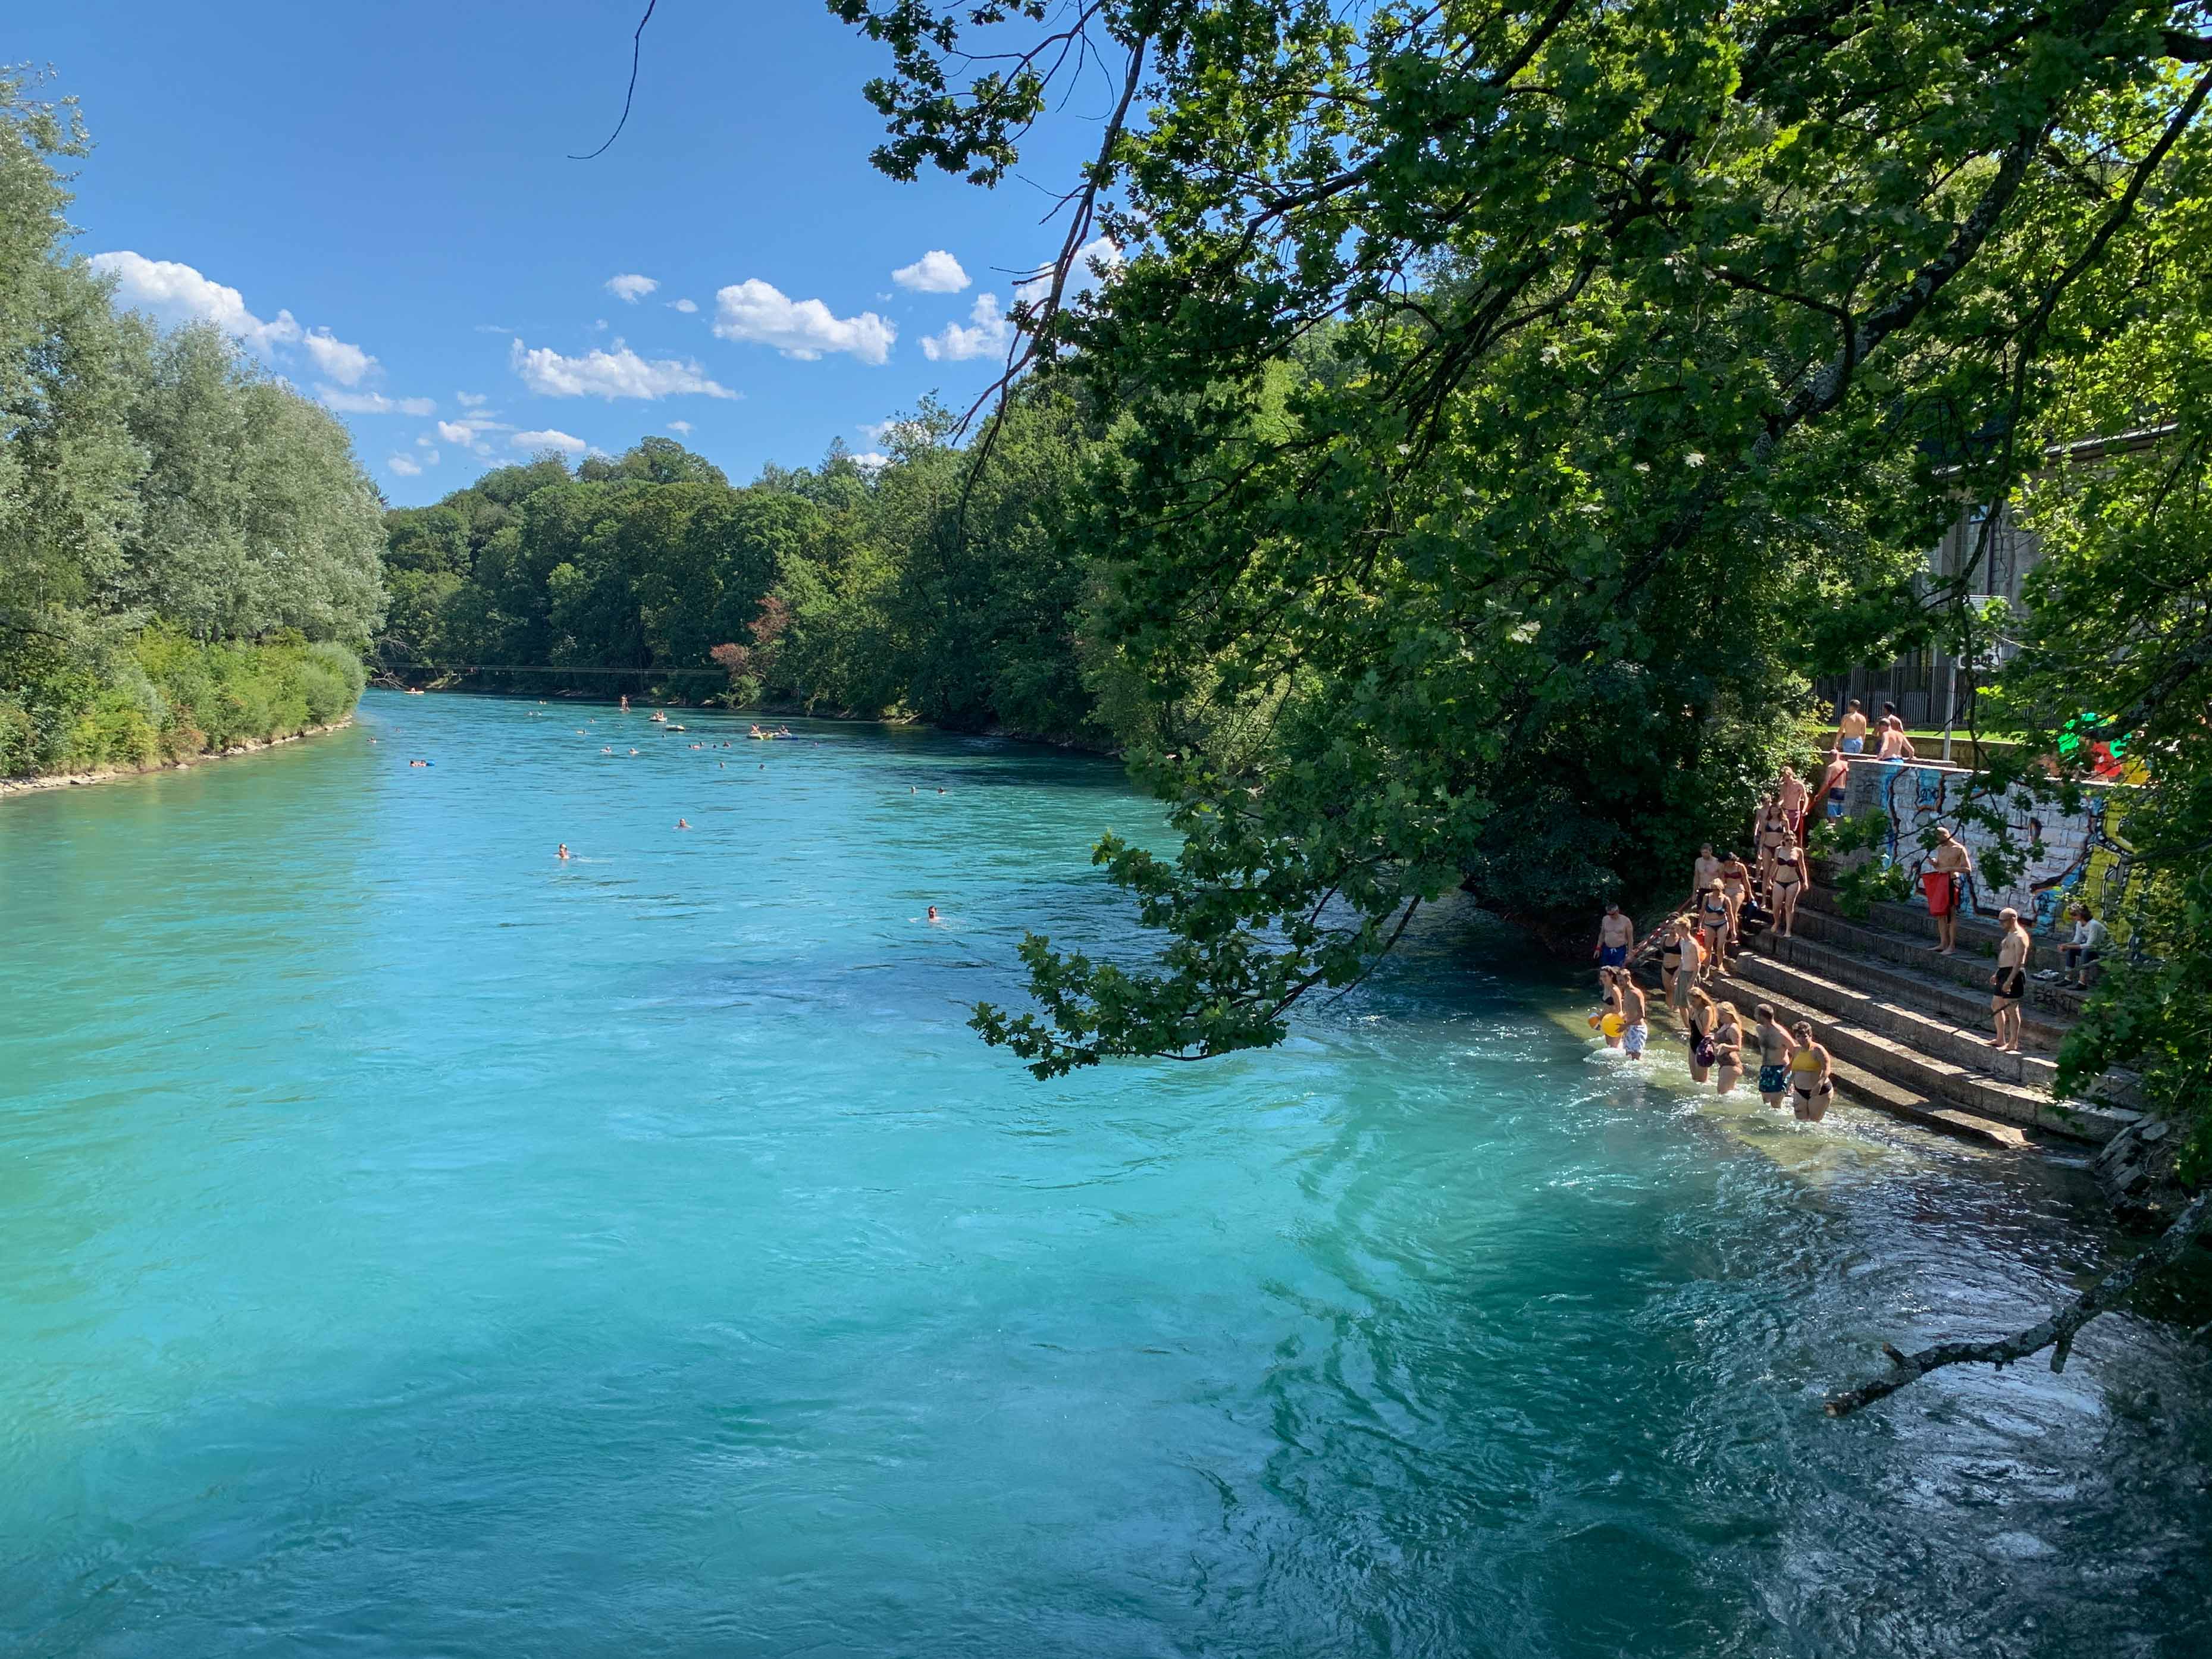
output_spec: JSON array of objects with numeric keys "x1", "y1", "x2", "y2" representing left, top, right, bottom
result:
[{"x1": 1845, "y1": 761, "x2": 2135, "y2": 936}]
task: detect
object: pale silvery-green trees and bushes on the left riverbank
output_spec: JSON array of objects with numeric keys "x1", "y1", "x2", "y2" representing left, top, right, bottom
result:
[{"x1": 0, "y1": 77, "x2": 383, "y2": 774}]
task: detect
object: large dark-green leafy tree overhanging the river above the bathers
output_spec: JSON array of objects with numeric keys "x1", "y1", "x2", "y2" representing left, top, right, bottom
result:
[{"x1": 832, "y1": 0, "x2": 2212, "y2": 1075}]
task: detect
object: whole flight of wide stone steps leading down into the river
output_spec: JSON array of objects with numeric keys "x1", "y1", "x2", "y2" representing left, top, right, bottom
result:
[{"x1": 1712, "y1": 887, "x2": 2141, "y2": 1146}]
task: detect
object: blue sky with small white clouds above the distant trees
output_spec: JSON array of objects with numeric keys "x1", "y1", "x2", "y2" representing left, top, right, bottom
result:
[{"x1": 21, "y1": 0, "x2": 1106, "y2": 504}]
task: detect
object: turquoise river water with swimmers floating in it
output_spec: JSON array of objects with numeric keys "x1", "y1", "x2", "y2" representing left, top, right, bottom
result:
[{"x1": 0, "y1": 695, "x2": 2212, "y2": 1659}]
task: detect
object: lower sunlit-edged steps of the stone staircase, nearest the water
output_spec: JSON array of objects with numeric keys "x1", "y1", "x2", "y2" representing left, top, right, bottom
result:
[{"x1": 1712, "y1": 968, "x2": 2139, "y2": 1141}]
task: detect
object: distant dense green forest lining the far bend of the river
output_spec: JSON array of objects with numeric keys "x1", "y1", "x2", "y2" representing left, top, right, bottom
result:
[{"x1": 380, "y1": 385, "x2": 1123, "y2": 741}]
